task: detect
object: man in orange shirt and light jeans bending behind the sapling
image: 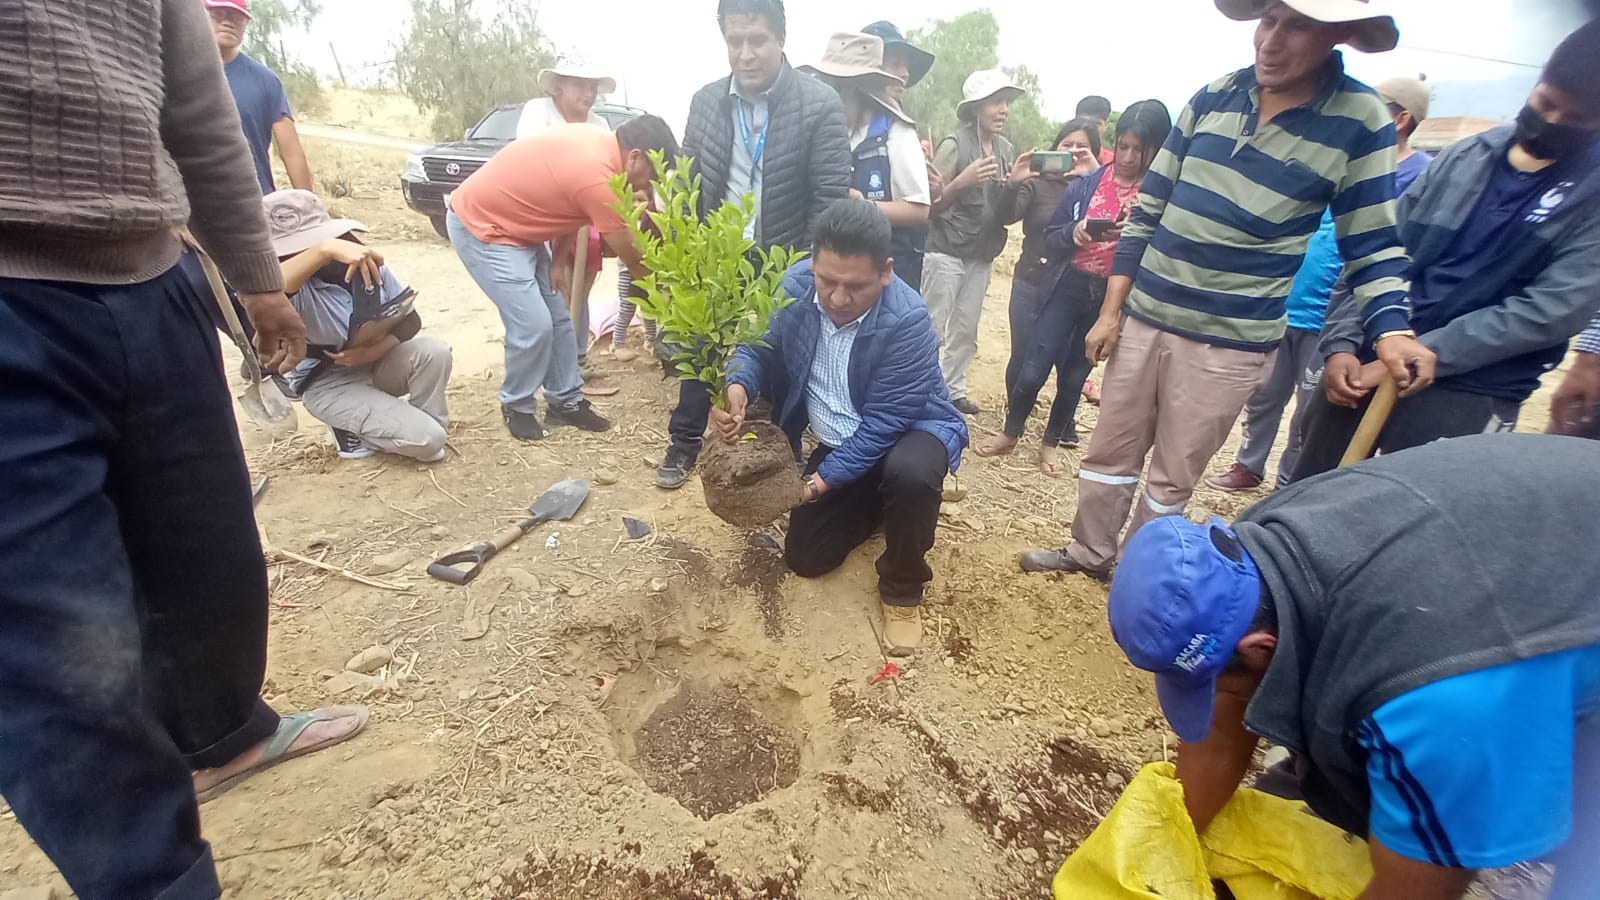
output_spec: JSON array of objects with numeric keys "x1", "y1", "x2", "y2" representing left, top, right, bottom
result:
[{"x1": 446, "y1": 115, "x2": 678, "y2": 440}]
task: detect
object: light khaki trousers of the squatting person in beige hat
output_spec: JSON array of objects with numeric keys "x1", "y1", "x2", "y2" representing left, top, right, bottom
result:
[{"x1": 302, "y1": 335, "x2": 451, "y2": 460}]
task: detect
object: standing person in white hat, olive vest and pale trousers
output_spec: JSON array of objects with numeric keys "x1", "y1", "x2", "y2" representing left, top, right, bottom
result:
[{"x1": 922, "y1": 69, "x2": 1034, "y2": 415}]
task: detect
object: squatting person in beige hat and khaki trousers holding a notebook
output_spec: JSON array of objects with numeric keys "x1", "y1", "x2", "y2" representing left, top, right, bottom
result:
[{"x1": 262, "y1": 191, "x2": 451, "y2": 463}]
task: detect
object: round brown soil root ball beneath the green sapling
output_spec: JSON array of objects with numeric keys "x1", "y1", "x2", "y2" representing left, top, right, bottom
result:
[{"x1": 699, "y1": 421, "x2": 800, "y2": 528}]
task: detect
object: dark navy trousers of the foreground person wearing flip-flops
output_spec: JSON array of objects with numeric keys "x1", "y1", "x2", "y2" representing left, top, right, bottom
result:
[{"x1": 0, "y1": 267, "x2": 278, "y2": 900}]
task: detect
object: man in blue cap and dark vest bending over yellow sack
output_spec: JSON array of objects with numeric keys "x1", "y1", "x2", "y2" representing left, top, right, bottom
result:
[{"x1": 1109, "y1": 434, "x2": 1600, "y2": 900}]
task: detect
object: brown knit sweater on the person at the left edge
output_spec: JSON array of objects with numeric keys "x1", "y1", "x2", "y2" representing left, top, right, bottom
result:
[{"x1": 0, "y1": 0, "x2": 283, "y2": 293}]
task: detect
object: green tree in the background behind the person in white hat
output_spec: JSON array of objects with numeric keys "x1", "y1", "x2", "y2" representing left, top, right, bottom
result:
[{"x1": 904, "y1": 10, "x2": 1056, "y2": 152}]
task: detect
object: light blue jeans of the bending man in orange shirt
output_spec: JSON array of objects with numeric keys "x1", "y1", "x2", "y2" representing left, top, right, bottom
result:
[{"x1": 445, "y1": 211, "x2": 584, "y2": 413}]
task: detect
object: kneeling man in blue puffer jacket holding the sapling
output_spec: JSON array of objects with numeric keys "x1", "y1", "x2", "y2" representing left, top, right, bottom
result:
[{"x1": 712, "y1": 200, "x2": 968, "y2": 657}]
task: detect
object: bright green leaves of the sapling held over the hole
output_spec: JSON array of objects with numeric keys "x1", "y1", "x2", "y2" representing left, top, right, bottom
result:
[{"x1": 611, "y1": 152, "x2": 805, "y2": 405}]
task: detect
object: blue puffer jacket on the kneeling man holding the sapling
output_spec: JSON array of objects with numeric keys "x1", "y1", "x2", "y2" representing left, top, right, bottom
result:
[{"x1": 728, "y1": 259, "x2": 968, "y2": 485}]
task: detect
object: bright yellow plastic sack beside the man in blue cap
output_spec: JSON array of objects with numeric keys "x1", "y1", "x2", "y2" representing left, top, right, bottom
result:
[{"x1": 1053, "y1": 762, "x2": 1373, "y2": 900}]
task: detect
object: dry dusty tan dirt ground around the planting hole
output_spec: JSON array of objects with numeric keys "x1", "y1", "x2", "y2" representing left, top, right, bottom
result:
[{"x1": 0, "y1": 89, "x2": 1574, "y2": 900}]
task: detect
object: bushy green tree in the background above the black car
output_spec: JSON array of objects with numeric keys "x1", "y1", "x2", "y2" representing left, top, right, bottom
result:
[{"x1": 395, "y1": 0, "x2": 555, "y2": 141}]
